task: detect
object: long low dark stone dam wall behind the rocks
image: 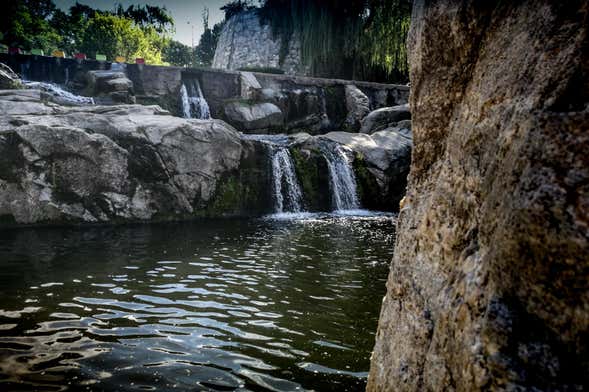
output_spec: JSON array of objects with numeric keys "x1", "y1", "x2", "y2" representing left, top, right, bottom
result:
[{"x1": 0, "y1": 54, "x2": 409, "y2": 134}]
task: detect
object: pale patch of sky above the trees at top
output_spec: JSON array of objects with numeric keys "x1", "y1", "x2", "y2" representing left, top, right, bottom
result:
[{"x1": 54, "y1": 0, "x2": 229, "y2": 45}]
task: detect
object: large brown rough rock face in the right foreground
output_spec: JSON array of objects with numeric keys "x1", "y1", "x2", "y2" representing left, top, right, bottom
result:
[{"x1": 368, "y1": 0, "x2": 589, "y2": 391}]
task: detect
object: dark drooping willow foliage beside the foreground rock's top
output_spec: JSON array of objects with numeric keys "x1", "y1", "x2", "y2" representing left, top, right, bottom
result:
[{"x1": 260, "y1": 0, "x2": 411, "y2": 81}]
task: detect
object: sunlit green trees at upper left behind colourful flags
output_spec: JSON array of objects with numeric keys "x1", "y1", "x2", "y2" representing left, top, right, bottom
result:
[{"x1": 0, "y1": 0, "x2": 174, "y2": 64}]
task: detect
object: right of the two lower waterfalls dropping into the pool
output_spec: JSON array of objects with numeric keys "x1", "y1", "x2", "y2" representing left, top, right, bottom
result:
[{"x1": 324, "y1": 143, "x2": 360, "y2": 211}]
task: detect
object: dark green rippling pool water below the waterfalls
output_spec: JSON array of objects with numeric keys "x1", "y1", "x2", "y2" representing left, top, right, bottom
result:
[{"x1": 0, "y1": 216, "x2": 394, "y2": 391}]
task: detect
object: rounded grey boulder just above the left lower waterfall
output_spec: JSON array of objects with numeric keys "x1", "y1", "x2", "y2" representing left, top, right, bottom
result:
[{"x1": 225, "y1": 101, "x2": 284, "y2": 133}]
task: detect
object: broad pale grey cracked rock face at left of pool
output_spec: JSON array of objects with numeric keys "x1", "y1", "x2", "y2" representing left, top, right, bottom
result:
[{"x1": 0, "y1": 90, "x2": 242, "y2": 225}]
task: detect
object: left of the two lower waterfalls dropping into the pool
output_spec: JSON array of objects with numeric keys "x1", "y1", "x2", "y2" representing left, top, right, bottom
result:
[{"x1": 272, "y1": 146, "x2": 303, "y2": 213}]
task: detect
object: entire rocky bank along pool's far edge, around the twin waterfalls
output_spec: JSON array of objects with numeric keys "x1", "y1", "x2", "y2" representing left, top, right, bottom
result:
[{"x1": 0, "y1": 89, "x2": 411, "y2": 226}]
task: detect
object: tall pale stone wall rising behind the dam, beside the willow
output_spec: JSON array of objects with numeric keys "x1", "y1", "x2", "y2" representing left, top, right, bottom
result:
[{"x1": 213, "y1": 10, "x2": 305, "y2": 75}]
